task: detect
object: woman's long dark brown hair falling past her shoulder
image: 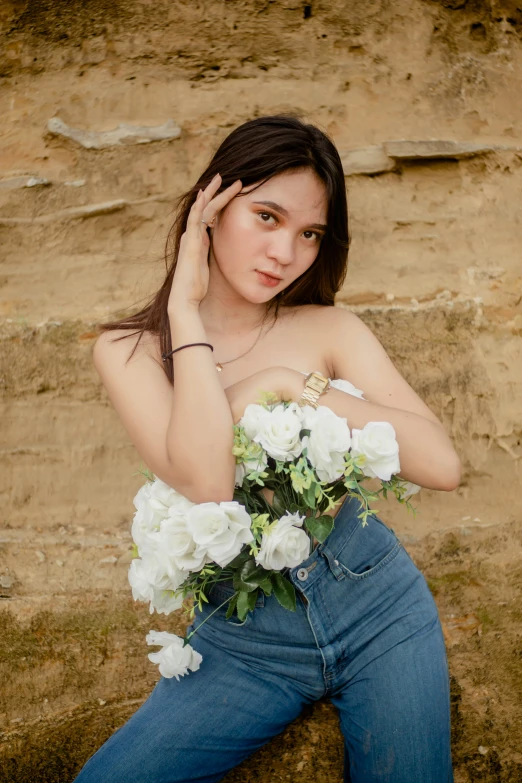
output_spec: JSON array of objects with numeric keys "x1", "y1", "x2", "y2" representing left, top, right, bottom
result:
[{"x1": 99, "y1": 115, "x2": 351, "y2": 383}]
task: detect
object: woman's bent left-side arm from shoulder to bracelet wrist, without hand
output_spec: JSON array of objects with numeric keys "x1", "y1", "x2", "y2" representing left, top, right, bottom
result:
[{"x1": 93, "y1": 311, "x2": 235, "y2": 503}]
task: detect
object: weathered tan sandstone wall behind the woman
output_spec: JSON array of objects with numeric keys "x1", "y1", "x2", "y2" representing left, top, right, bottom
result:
[{"x1": 0, "y1": 0, "x2": 522, "y2": 783}]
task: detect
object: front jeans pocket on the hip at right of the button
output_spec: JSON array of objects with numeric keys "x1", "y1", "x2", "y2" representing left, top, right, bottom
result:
[{"x1": 335, "y1": 516, "x2": 402, "y2": 580}]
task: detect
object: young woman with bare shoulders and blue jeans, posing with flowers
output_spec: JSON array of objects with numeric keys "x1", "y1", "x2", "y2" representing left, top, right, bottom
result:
[{"x1": 77, "y1": 116, "x2": 460, "y2": 783}]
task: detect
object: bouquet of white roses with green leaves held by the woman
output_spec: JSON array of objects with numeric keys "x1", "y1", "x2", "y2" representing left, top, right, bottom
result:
[{"x1": 129, "y1": 381, "x2": 420, "y2": 678}]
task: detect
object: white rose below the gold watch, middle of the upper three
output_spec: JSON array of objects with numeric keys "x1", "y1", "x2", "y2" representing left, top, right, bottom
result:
[{"x1": 302, "y1": 405, "x2": 352, "y2": 483}]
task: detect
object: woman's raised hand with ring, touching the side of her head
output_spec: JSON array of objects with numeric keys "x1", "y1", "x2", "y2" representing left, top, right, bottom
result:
[{"x1": 168, "y1": 174, "x2": 242, "y2": 311}]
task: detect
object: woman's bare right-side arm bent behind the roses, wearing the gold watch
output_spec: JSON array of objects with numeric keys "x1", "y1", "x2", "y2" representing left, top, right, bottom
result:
[{"x1": 286, "y1": 307, "x2": 461, "y2": 492}]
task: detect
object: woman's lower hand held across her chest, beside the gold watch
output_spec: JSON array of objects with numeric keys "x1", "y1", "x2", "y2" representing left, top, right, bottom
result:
[{"x1": 225, "y1": 367, "x2": 304, "y2": 424}]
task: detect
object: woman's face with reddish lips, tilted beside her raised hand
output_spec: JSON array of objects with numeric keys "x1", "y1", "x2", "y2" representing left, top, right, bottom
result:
[{"x1": 207, "y1": 169, "x2": 327, "y2": 303}]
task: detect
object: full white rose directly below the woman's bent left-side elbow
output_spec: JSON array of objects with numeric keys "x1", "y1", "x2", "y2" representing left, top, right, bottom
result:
[{"x1": 187, "y1": 500, "x2": 254, "y2": 568}]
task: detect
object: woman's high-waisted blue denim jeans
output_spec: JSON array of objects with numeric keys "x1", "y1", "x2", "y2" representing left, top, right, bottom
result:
[{"x1": 76, "y1": 498, "x2": 453, "y2": 783}]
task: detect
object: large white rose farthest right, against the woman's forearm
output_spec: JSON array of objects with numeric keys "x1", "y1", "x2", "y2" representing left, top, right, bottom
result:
[{"x1": 351, "y1": 421, "x2": 401, "y2": 481}]
